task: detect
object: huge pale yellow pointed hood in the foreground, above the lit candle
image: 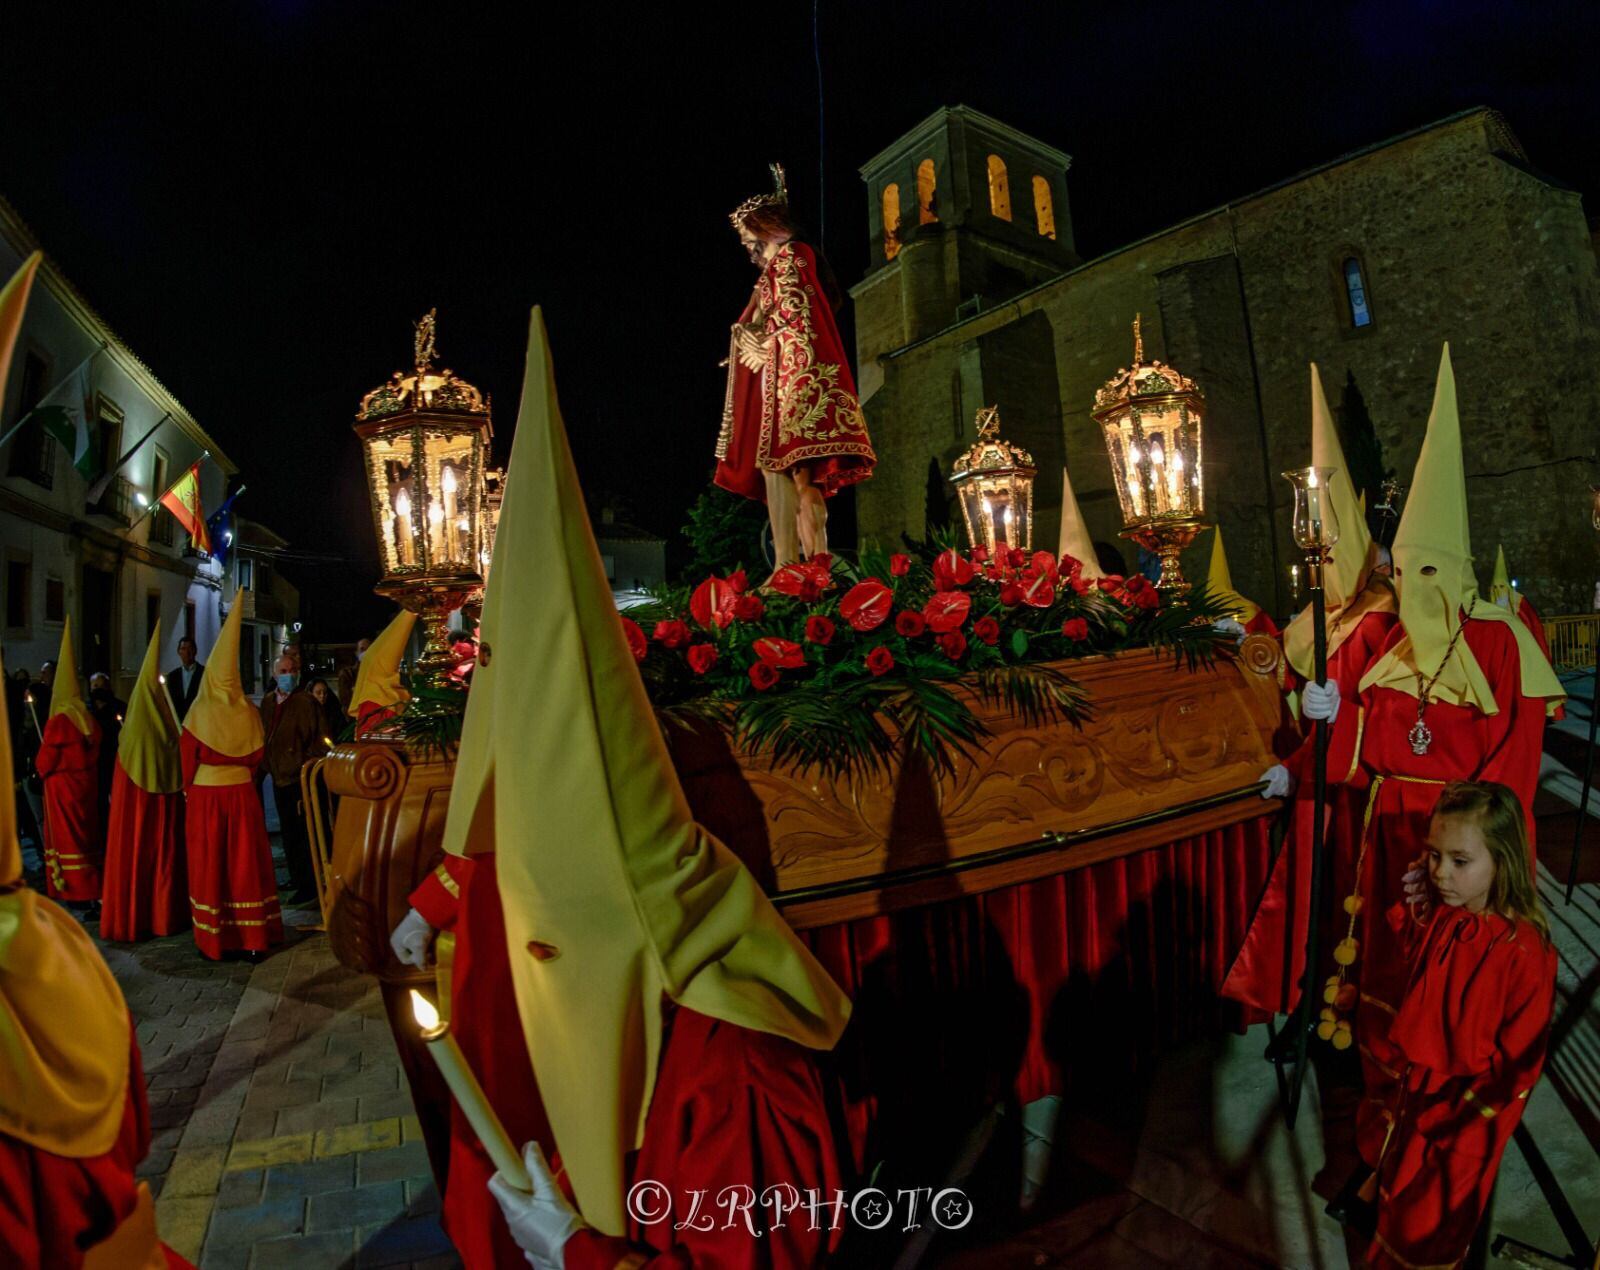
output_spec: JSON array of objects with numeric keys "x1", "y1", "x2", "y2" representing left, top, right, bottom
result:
[{"x1": 445, "y1": 309, "x2": 850, "y2": 1235}]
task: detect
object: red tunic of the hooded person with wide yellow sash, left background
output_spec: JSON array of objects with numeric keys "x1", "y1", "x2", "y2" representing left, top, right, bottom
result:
[{"x1": 179, "y1": 731, "x2": 283, "y2": 961}]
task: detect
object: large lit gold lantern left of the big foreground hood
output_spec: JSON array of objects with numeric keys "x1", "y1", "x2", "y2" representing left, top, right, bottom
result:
[{"x1": 355, "y1": 310, "x2": 494, "y2": 683}]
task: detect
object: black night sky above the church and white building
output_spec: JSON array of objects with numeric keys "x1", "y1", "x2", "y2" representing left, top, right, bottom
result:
[{"x1": 0, "y1": 0, "x2": 1600, "y2": 640}]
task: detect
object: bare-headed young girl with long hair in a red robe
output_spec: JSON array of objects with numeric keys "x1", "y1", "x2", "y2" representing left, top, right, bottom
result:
[{"x1": 1368, "y1": 781, "x2": 1555, "y2": 1270}]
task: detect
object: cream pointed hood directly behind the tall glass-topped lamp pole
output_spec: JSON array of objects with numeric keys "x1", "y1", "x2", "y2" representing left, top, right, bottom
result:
[{"x1": 1283, "y1": 361, "x2": 1395, "y2": 680}]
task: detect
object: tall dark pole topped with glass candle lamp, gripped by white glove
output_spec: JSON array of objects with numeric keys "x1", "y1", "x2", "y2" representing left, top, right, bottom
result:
[{"x1": 1283, "y1": 467, "x2": 1354, "y2": 1129}]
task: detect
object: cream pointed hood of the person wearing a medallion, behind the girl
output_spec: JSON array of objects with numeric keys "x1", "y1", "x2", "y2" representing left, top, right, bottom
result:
[{"x1": 1362, "y1": 344, "x2": 1565, "y2": 715}]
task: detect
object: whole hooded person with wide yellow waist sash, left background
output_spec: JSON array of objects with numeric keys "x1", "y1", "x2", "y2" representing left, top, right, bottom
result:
[{"x1": 179, "y1": 597, "x2": 283, "y2": 961}]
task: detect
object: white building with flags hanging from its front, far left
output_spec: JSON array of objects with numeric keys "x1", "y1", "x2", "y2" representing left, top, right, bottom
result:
[{"x1": 0, "y1": 198, "x2": 237, "y2": 693}]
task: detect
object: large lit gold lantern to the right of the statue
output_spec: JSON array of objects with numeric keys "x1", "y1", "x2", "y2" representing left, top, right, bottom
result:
[{"x1": 1091, "y1": 317, "x2": 1206, "y2": 590}]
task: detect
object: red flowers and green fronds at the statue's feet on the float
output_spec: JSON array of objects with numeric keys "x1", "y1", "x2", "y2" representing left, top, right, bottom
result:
[{"x1": 622, "y1": 541, "x2": 1232, "y2": 774}]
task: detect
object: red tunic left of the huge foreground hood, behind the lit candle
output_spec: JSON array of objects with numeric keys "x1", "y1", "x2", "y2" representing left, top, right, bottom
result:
[{"x1": 411, "y1": 854, "x2": 552, "y2": 1270}]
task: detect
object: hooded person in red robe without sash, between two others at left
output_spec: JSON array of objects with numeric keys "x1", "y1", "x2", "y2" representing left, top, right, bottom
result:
[{"x1": 101, "y1": 622, "x2": 189, "y2": 939}]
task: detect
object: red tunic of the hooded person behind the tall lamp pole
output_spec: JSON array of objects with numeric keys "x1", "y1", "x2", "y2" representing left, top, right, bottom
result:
[{"x1": 1222, "y1": 613, "x2": 1398, "y2": 1014}]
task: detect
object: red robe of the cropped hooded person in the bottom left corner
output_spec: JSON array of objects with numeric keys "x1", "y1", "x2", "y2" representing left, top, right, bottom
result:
[{"x1": 0, "y1": 1030, "x2": 189, "y2": 1270}]
